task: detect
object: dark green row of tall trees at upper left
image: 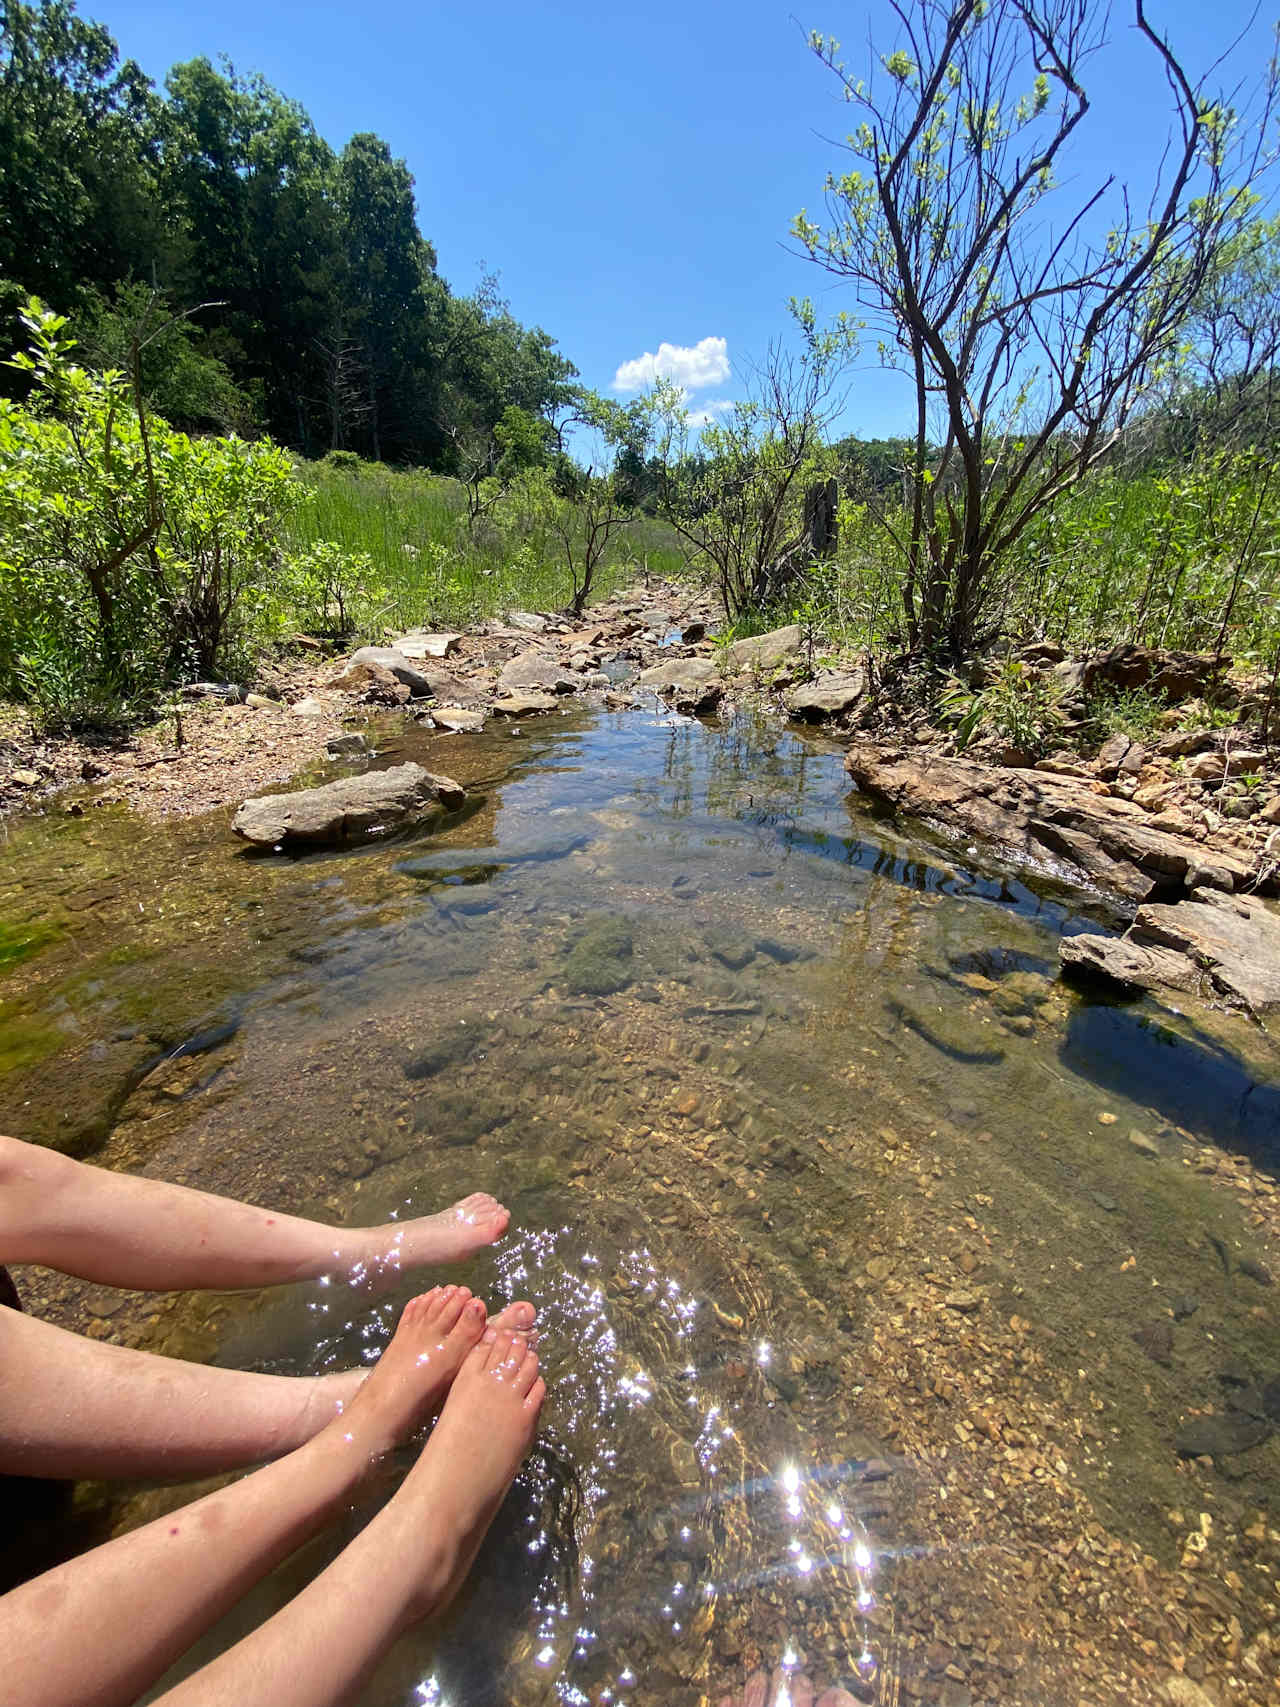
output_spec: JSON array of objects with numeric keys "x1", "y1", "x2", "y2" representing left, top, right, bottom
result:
[{"x1": 0, "y1": 0, "x2": 575, "y2": 471}]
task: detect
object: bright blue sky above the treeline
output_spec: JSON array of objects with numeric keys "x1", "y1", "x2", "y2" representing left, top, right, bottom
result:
[{"x1": 95, "y1": 0, "x2": 1271, "y2": 437}]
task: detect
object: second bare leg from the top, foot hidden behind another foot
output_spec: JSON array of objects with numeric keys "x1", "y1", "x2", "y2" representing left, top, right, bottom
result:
[{"x1": 0, "y1": 1302, "x2": 534, "y2": 1480}]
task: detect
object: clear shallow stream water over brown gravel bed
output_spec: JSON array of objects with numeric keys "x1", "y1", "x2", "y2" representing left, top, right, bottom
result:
[{"x1": 0, "y1": 708, "x2": 1280, "y2": 1707}]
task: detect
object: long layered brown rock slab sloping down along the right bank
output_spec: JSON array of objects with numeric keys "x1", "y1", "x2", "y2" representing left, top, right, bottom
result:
[{"x1": 845, "y1": 741, "x2": 1256, "y2": 906}]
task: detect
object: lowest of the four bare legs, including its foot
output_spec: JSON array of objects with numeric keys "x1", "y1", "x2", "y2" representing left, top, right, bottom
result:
[{"x1": 157, "y1": 1333, "x2": 546, "y2": 1707}]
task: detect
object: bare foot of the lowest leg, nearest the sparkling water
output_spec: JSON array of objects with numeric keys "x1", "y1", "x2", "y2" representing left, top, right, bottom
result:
[{"x1": 387, "y1": 1328, "x2": 546, "y2": 1623}]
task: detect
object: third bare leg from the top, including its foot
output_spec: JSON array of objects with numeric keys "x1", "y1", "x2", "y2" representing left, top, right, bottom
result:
[{"x1": 0, "y1": 1287, "x2": 509, "y2": 1707}]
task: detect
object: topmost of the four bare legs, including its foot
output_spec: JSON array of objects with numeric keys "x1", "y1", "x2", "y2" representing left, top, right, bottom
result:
[{"x1": 0, "y1": 1137, "x2": 510, "y2": 1290}]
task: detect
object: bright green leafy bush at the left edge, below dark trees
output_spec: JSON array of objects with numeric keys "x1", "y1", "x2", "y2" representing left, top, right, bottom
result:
[{"x1": 0, "y1": 302, "x2": 299, "y2": 724}]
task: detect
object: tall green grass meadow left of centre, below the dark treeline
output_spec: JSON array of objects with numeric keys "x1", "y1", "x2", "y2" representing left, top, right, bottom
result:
[{"x1": 282, "y1": 463, "x2": 696, "y2": 633}]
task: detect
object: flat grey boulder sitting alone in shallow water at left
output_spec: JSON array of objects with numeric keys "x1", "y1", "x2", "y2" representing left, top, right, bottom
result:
[{"x1": 232, "y1": 765, "x2": 466, "y2": 847}]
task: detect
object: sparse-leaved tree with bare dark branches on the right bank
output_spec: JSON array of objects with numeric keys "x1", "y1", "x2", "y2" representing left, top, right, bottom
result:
[{"x1": 794, "y1": 0, "x2": 1275, "y2": 661}]
